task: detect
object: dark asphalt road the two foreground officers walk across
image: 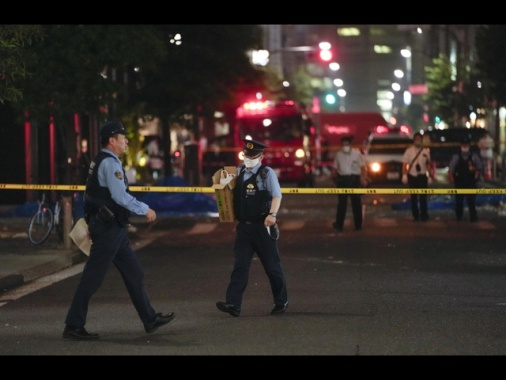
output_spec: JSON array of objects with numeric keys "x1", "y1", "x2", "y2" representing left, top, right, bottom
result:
[{"x1": 0, "y1": 194, "x2": 506, "y2": 356}]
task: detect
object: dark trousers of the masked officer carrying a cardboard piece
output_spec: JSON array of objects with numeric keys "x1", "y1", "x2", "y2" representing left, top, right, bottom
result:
[{"x1": 226, "y1": 222, "x2": 288, "y2": 310}]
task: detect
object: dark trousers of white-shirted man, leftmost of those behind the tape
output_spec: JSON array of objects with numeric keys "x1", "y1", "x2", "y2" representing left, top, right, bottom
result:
[{"x1": 336, "y1": 175, "x2": 362, "y2": 230}]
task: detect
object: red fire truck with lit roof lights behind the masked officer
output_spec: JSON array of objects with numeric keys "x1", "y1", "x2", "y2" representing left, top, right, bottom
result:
[{"x1": 234, "y1": 100, "x2": 317, "y2": 187}]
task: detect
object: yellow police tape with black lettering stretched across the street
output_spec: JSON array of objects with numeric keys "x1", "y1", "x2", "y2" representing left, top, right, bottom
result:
[{"x1": 0, "y1": 183, "x2": 506, "y2": 195}]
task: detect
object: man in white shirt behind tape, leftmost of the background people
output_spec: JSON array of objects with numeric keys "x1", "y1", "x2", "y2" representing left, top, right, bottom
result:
[{"x1": 332, "y1": 136, "x2": 367, "y2": 232}]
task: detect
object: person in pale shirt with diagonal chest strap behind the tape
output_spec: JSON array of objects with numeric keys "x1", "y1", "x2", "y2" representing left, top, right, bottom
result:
[{"x1": 402, "y1": 132, "x2": 434, "y2": 222}]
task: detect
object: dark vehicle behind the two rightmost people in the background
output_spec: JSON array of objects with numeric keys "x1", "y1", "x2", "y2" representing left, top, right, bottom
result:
[{"x1": 421, "y1": 127, "x2": 486, "y2": 169}]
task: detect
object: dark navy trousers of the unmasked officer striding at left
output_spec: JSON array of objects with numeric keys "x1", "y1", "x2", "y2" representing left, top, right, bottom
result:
[{"x1": 65, "y1": 216, "x2": 156, "y2": 327}]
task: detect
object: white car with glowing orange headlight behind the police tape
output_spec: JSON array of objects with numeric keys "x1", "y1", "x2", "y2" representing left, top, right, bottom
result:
[{"x1": 364, "y1": 129, "x2": 413, "y2": 185}]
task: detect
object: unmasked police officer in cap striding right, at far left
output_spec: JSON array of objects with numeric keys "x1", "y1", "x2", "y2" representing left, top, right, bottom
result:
[{"x1": 63, "y1": 121, "x2": 174, "y2": 340}]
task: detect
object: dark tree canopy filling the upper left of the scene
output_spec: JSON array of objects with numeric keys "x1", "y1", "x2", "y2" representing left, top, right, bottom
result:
[{"x1": 0, "y1": 25, "x2": 261, "y2": 126}]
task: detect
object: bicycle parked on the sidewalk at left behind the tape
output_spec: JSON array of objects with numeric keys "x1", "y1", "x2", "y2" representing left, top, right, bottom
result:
[{"x1": 28, "y1": 193, "x2": 67, "y2": 245}]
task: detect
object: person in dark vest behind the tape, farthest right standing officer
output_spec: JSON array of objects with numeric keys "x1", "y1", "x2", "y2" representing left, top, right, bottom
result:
[{"x1": 448, "y1": 138, "x2": 483, "y2": 222}]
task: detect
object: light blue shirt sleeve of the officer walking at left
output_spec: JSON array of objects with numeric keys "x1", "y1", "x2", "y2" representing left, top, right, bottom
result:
[{"x1": 97, "y1": 148, "x2": 149, "y2": 215}]
